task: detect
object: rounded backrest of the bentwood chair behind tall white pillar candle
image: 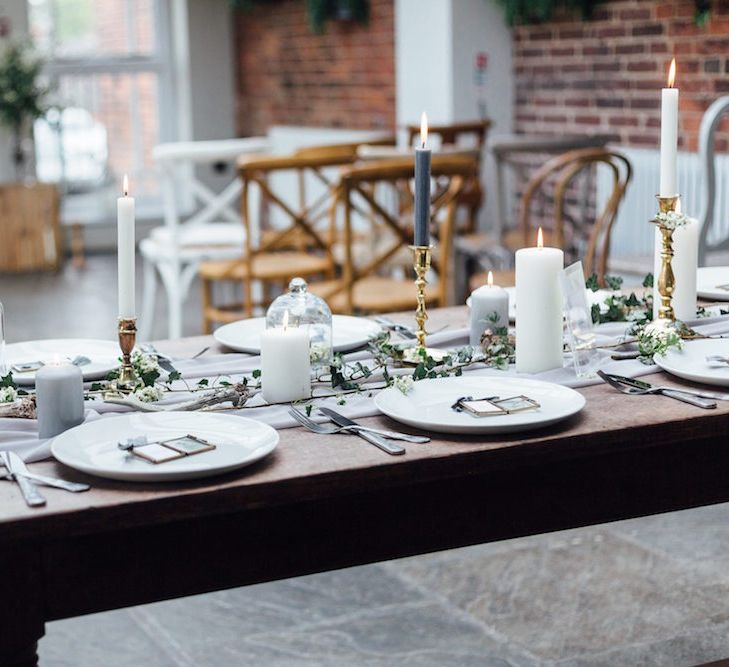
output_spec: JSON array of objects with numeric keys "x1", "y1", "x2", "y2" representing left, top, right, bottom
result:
[{"x1": 520, "y1": 148, "x2": 633, "y2": 284}]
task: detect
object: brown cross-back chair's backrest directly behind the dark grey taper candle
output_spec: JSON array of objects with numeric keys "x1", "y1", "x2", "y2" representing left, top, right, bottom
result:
[{"x1": 326, "y1": 155, "x2": 478, "y2": 312}]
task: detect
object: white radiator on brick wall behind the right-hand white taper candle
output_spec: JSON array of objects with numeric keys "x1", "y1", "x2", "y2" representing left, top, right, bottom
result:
[{"x1": 597, "y1": 146, "x2": 729, "y2": 259}]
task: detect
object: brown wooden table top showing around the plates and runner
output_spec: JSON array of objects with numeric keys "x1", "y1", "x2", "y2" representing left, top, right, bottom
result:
[{"x1": 0, "y1": 308, "x2": 729, "y2": 545}]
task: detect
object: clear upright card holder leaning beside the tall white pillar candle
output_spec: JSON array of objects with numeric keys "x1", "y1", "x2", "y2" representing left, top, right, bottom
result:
[{"x1": 559, "y1": 262, "x2": 606, "y2": 378}]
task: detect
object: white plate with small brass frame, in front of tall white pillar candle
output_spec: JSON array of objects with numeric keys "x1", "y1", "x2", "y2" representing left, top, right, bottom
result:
[{"x1": 375, "y1": 375, "x2": 585, "y2": 433}]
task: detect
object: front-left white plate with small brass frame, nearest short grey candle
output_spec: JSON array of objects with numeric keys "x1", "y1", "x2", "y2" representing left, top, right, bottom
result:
[{"x1": 51, "y1": 412, "x2": 278, "y2": 482}]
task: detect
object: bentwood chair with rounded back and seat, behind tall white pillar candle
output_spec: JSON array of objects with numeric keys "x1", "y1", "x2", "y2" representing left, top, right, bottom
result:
[{"x1": 471, "y1": 148, "x2": 633, "y2": 288}]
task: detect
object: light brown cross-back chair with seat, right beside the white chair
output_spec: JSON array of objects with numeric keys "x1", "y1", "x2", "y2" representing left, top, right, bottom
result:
[{"x1": 199, "y1": 147, "x2": 355, "y2": 332}]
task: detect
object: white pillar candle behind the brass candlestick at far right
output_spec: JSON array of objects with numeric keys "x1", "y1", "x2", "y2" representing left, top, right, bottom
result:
[{"x1": 653, "y1": 214, "x2": 699, "y2": 322}]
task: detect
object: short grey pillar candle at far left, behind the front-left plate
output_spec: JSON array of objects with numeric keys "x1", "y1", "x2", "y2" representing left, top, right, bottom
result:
[{"x1": 35, "y1": 364, "x2": 84, "y2": 438}]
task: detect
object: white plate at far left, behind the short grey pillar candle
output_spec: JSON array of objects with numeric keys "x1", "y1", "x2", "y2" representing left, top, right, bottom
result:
[{"x1": 5, "y1": 338, "x2": 121, "y2": 385}]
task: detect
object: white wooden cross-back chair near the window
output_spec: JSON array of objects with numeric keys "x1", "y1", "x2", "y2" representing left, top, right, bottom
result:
[{"x1": 139, "y1": 137, "x2": 268, "y2": 340}]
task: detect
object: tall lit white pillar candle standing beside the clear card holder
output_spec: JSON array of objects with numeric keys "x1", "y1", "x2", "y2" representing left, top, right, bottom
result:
[{"x1": 516, "y1": 227, "x2": 564, "y2": 373}]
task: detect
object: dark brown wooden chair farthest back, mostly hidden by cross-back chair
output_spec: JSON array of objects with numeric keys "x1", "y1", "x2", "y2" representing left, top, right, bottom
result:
[{"x1": 407, "y1": 118, "x2": 491, "y2": 234}]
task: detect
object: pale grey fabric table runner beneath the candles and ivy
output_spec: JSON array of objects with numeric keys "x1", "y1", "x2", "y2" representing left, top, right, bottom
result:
[{"x1": 7, "y1": 316, "x2": 729, "y2": 461}]
